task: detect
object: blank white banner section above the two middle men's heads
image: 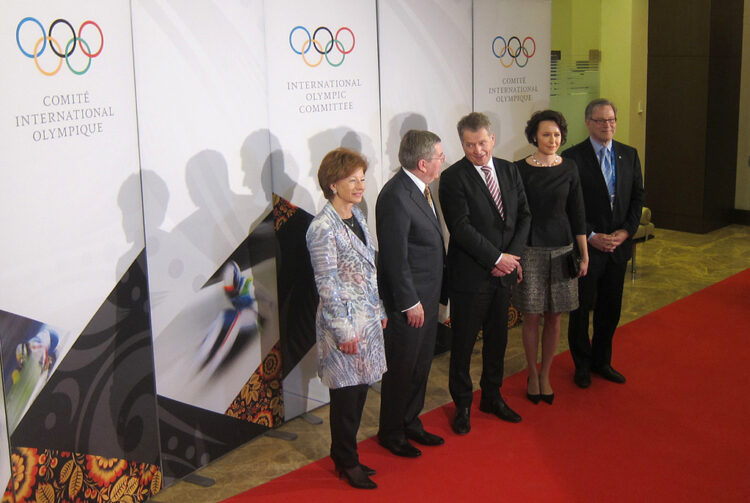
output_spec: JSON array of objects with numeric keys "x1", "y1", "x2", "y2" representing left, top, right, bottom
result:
[{"x1": 378, "y1": 0, "x2": 472, "y2": 173}]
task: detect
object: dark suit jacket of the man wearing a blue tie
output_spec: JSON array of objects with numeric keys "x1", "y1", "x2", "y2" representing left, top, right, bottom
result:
[{"x1": 562, "y1": 138, "x2": 644, "y2": 263}]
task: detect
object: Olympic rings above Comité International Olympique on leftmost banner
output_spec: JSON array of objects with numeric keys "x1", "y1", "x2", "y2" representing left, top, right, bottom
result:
[{"x1": 16, "y1": 17, "x2": 104, "y2": 77}]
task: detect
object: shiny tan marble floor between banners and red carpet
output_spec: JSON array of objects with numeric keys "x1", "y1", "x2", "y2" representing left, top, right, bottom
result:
[{"x1": 151, "y1": 225, "x2": 750, "y2": 503}]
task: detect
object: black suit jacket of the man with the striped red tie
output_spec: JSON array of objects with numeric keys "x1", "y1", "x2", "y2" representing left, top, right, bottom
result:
[{"x1": 440, "y1": 157, "x2": 531, "y2": 292}]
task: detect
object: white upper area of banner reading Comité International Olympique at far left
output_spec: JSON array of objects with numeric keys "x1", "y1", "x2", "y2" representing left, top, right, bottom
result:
[{"x1": 0, "y1": 0, "x2": 143, "y2": 338}]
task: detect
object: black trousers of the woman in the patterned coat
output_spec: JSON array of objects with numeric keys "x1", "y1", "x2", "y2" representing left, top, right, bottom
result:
[{"x1": 329, "y1": 384, "x2": 368, "y2": 468}]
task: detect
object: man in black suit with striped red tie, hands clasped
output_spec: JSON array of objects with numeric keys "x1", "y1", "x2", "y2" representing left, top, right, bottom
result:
[{"x1": 439, "y1": 112, "x2": 531, "y2": 435}]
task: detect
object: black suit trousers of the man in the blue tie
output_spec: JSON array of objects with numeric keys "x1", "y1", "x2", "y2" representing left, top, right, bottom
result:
[{"x1": 568, "y1": 248, "x2": 627, "y2": 370}]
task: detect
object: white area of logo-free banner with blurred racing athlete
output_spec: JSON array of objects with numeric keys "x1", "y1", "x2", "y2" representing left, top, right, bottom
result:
[{"x1": 133, "y1": 0, "x2": 278, "y2": 414}]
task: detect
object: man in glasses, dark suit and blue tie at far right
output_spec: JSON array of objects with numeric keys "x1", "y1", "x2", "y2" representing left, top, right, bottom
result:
[{"x1": 562, "y1": 98, "x2": 644, "y2": 388}]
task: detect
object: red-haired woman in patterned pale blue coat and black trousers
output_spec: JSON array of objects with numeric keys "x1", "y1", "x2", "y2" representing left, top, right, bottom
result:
[{"x1": 307, "y1": 148, "x2": 387, "y2": 489}]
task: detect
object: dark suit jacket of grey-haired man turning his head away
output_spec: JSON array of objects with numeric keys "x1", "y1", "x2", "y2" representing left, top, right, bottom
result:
[{"x1": 375, "y1": 169, "x2": 445, "y2": 316}]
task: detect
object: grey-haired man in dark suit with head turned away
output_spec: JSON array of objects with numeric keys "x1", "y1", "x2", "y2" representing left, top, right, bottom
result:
[{"x1": 375, "y1": 129, "x2": 445, "y2": 458}]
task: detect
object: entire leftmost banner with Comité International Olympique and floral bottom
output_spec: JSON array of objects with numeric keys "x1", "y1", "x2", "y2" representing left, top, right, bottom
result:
[{"x1": 0, "y1": 0, "x2": 159, "y2": 501}]
